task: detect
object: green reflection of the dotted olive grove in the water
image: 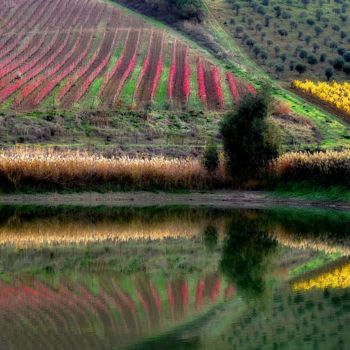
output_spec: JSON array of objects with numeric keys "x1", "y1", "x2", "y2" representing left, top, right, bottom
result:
[{"x1": 202, "y1": 288, "x2": 350, "y2": 350}]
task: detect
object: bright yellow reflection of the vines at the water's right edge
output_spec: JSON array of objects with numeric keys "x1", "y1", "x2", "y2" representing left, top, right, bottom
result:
[{"x1": 291, "y1": 260, "x2": 350, "y2": 291}]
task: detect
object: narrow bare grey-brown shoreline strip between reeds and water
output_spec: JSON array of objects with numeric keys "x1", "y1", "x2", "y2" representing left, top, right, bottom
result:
[{"x1": 0, "y1": 190, "x2": 350, "y2": 211}]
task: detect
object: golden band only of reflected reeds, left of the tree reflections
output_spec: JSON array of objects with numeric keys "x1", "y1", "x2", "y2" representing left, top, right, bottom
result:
[{"x1": 0, "y1": 220, "x2": 213, "y2": 248}]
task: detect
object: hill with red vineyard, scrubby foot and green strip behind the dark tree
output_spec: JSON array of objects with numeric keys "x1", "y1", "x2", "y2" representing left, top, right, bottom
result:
[{"x1": 0, "y1": 0, "x2": 350, "y2": 155}]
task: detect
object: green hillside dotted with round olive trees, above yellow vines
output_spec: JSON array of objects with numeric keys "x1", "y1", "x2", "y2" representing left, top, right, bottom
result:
[{"x1": 210, "y1": 0, "x2": 350, "y2": 81}]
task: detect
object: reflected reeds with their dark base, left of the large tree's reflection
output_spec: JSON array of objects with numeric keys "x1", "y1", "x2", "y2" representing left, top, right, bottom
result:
[{"x1": 0, "y1": 206, "x2": 227, "y2": 248}]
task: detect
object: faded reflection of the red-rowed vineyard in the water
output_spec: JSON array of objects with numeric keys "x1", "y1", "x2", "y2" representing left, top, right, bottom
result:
[{"x1": 0, "y1": 273, "x2": 234, "y2": 349}]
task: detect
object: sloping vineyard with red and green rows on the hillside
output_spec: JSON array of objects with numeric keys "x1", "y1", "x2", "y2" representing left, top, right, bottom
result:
[{"x1": 0, "y1": 0, "x2": 254, "y2": 110}]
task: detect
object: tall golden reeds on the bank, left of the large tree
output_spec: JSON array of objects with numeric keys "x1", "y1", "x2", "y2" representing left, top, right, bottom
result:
[{"x1": 0, "y1": 148, "x2": 228, "y2": 190}]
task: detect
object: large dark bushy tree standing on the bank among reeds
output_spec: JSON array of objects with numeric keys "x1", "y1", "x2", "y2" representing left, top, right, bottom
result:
[{"x1": 221, "y1": 87, "x2": 278, "y2": 180}]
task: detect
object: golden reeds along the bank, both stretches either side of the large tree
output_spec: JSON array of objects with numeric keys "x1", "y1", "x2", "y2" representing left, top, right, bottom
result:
[{"x1": 0, "y1": 147, "x2": 350, "y2": 191}]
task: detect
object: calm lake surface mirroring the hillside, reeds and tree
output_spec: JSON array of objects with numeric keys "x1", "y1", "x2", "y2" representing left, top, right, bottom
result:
[{"x1": 0, "y1": 206, "x2": 350, "y2": 350}]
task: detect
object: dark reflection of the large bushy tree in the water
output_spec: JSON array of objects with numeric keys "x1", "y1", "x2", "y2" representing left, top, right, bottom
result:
[{"x1": 220, "y1": 217, "x2": 277, "y2": 297}]
